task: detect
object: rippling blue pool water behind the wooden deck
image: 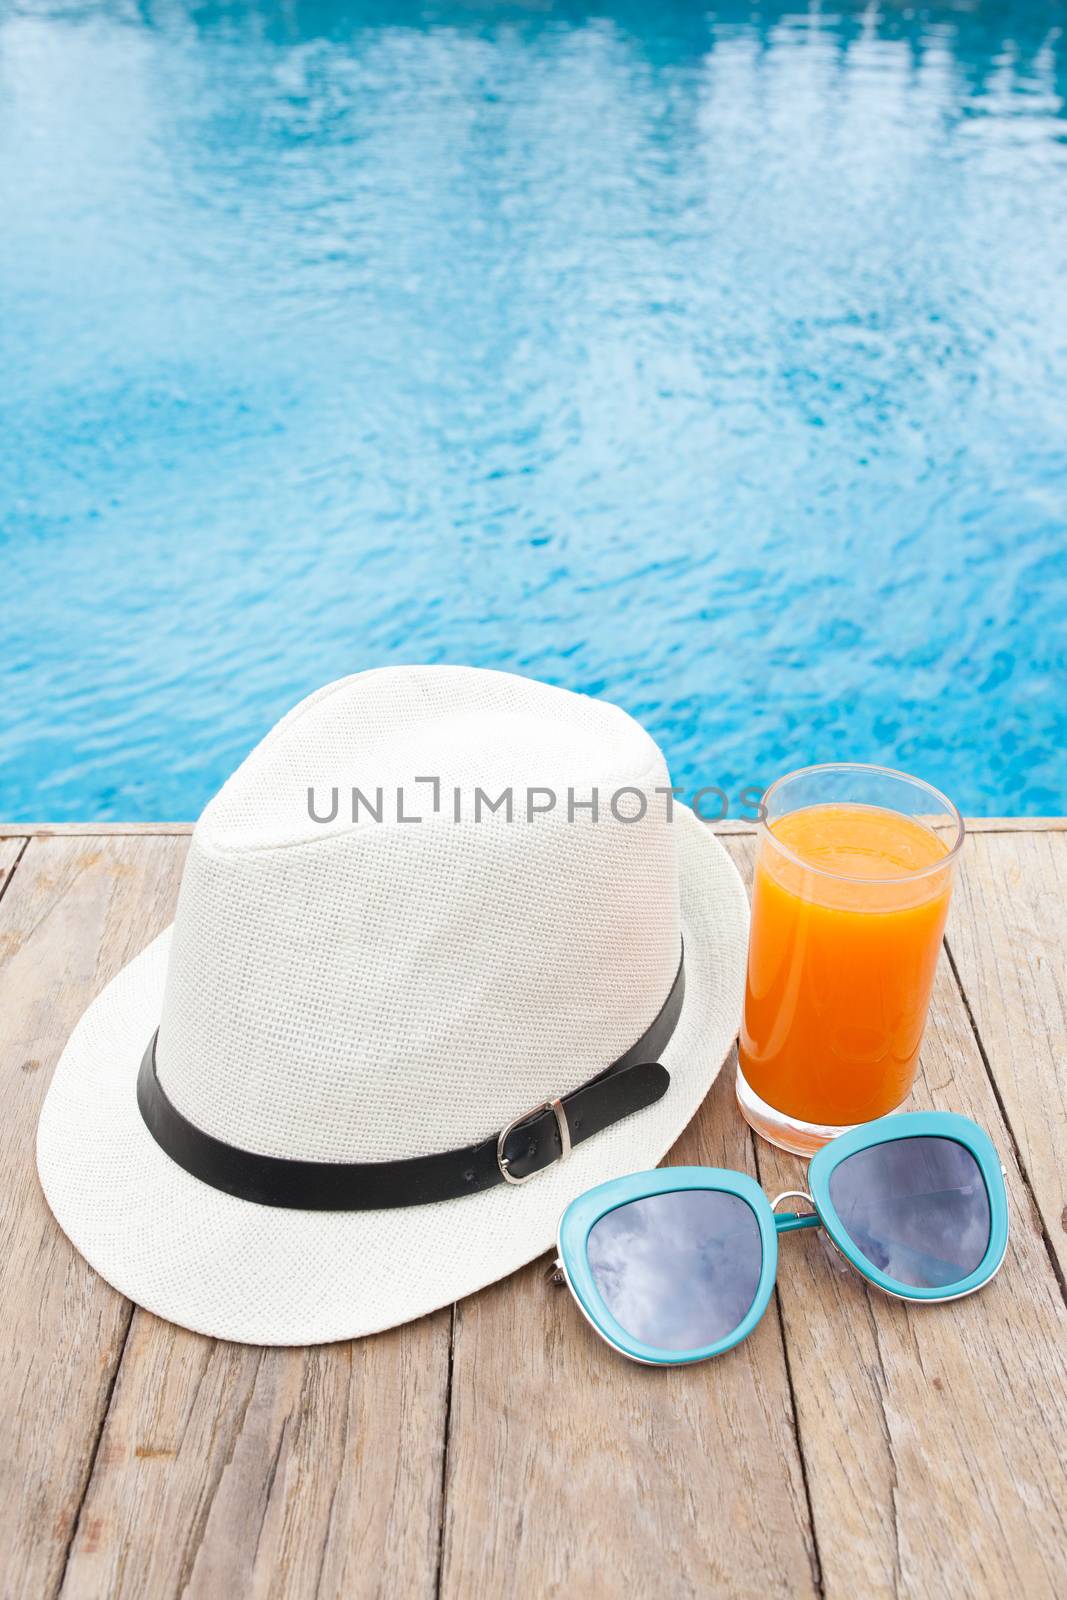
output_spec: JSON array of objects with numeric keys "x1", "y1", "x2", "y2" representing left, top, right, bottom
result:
[{"x1": 0, "y1": 0, "x2": 1067, "y2": 819}]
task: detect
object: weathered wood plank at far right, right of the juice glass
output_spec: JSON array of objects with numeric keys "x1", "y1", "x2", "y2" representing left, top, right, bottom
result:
[{"x1": 949, "y1": 834, "x2": 1067, "y2": 1277}]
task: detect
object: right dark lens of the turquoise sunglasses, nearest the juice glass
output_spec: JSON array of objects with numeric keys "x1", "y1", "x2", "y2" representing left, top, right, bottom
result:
[{"x1": 830, "y1": 1136, "x2": 990, "y2": 1290}]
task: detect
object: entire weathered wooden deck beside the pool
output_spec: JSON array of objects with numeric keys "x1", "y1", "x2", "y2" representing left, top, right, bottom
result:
[{"x1": 0, "y1": 819, "x2": 1067, "y2": 1600}]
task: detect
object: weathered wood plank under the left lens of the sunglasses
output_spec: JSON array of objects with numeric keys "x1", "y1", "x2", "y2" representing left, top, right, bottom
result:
[{"x1": 442, "y1": 1062, "x2": 816, "y2": 1600}]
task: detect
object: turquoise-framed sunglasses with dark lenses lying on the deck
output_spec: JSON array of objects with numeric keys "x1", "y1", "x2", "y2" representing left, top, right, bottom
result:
[{"x1": 552, "y1": 1112, "x2": 1008, "y2": 1366}]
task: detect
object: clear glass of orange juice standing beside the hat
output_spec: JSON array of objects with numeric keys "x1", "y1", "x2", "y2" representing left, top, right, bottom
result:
[{"x1": 737, "y1": 763, "x2": 963, "y2": 1155}]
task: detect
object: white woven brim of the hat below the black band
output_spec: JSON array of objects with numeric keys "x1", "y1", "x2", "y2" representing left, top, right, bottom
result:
[{"x1": 37, "y1": 806, "x2": 749, "y2": 1344}]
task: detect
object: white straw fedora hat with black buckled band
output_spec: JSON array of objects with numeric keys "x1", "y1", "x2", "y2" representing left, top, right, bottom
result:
[{"x1": 37, "y1": 667, "x2": 747, "y2": 1344}]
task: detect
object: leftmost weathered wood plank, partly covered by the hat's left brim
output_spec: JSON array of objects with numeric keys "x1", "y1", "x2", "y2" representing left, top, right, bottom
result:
[{"x1": 0, "y1": 838, "x2": 186, "y2": 1600}]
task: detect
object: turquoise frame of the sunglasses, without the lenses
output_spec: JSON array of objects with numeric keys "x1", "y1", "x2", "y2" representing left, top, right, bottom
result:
[{"x1": 557, "y1": 1110, "x2": 1008, "y2": 1366}]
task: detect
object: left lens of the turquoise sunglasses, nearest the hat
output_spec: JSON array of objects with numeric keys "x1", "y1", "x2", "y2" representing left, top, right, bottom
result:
[{"x1": 587, "y1": 1189, "x2": 763, "y2": 1350}]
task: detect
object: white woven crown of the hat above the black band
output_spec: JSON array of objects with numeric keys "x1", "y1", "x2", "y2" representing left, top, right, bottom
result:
[{"x1": 157, "y1": 667, "x2": 680, "y2": 1162}]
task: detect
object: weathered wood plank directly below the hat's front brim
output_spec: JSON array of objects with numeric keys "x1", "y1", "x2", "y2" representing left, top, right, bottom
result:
[{"x1": 62, "y1": 1305, "x2": 451, "y2": 1600}]
